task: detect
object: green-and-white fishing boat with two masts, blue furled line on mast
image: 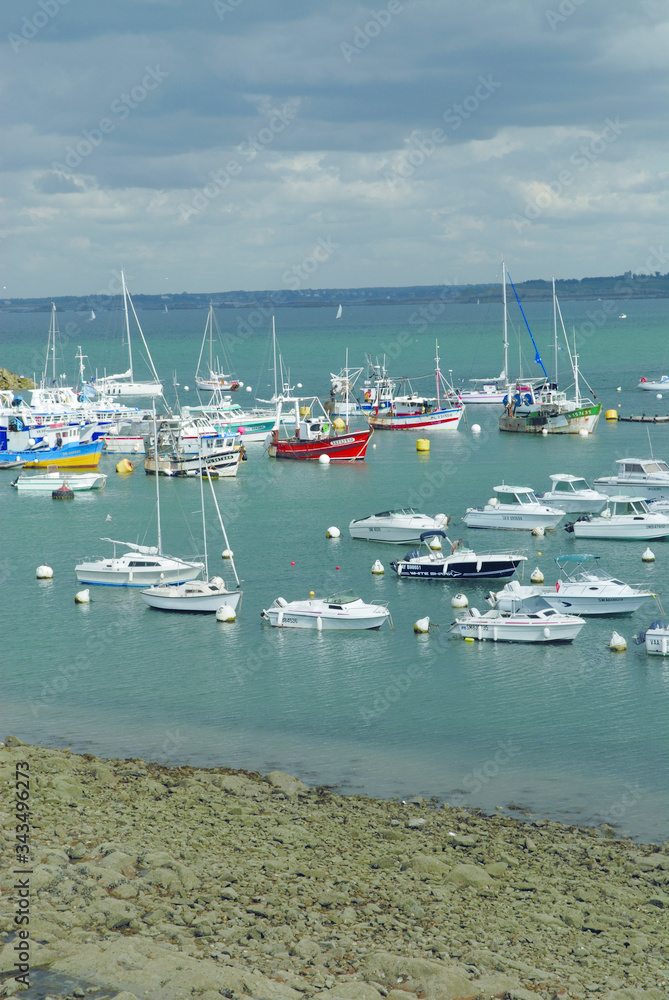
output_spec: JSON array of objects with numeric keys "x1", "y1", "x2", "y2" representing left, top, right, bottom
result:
[{"x1": 499, "y1": 272, "x2": 602, "y2": 434}]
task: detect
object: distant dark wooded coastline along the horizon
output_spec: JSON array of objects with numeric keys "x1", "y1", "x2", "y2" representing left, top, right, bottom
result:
[{"x1": 5, "y1": 271, "x2": 669, "y2": 312}]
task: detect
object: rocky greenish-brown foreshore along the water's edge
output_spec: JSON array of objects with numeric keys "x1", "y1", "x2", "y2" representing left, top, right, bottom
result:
[{"x1": 0, "y1": 737, "x2": 669, "y2": 1000}]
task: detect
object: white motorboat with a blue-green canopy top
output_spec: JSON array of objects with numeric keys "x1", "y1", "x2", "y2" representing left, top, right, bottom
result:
[{"x1": 488, "y1": 553, "x2": 653, "y2": 615}]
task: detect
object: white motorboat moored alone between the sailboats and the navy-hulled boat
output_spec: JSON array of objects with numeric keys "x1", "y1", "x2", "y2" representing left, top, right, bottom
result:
[{"x1": 261, "y1": 590, "x2": 390, "y2": 632}]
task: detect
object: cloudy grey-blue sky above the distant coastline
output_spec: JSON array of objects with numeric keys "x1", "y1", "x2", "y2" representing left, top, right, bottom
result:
[{"x1": 0, "y1": 0, "x2": 669, "y2": 298}]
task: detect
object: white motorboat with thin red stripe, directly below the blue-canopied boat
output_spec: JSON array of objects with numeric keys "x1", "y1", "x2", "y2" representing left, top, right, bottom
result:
[{"x1": 450, "y1": 608, "x2": 585, "y2": 642}]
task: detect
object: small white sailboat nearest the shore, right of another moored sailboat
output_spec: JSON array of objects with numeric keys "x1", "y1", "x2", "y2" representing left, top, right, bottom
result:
[{"x1": 140, "y1": 459, "x2": 242, "y2": 613}]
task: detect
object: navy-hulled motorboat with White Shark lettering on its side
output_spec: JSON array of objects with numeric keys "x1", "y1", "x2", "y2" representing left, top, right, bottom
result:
[{"x1": 390, "y1": 531, "x2": 527, "y2": 580}]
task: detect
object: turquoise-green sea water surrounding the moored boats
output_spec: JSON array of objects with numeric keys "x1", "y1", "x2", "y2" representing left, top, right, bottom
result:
[{"x1": 0, "y1": 300, "x2": 669, "y2": 841}]
